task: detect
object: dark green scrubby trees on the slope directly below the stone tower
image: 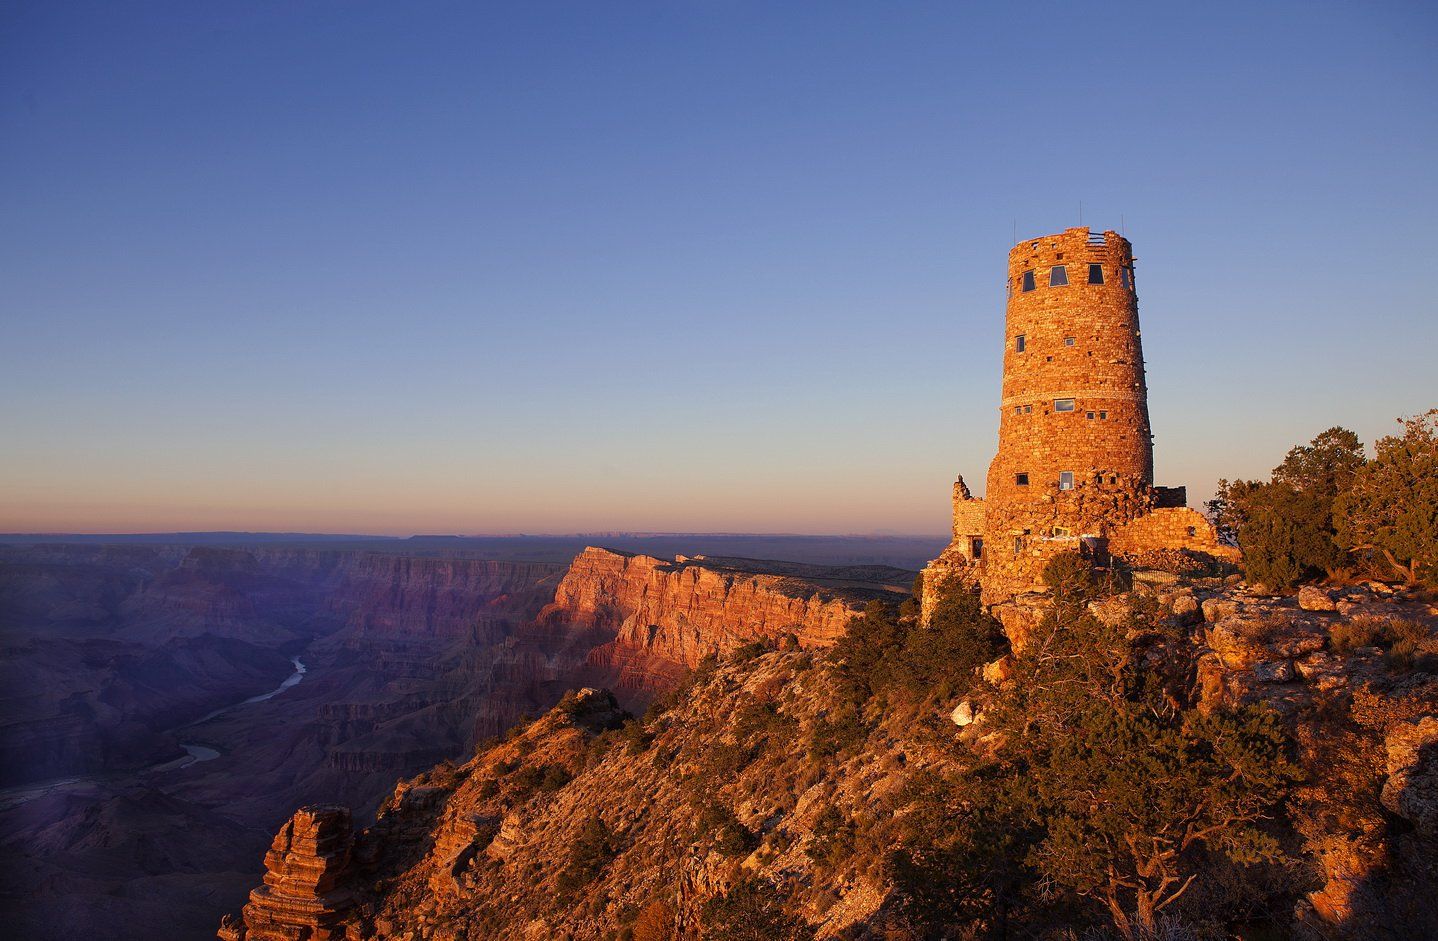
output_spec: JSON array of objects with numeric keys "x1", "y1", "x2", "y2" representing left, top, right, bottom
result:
[{"x1": 870, "y1": 555, "x2": 1297, "y2": 937}]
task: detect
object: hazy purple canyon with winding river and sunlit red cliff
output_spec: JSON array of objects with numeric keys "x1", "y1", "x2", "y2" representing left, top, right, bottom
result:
[{"x1": 0, "y1": 537, "x2": 930, "y2": 938}]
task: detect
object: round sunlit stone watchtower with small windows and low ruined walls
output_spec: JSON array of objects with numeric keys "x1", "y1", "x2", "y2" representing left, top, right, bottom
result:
[{"x1": 925, "y1": 229, "x2": 1235, "y2": 624}]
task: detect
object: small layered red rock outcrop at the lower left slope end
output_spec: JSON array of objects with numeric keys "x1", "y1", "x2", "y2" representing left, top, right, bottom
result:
[{"x1": 219, "y1": 806, "x2": 362, "y2": 941}]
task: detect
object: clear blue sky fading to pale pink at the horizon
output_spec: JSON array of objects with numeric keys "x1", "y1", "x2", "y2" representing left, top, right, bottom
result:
[{"x1": 0, "y1": 0, "x2": 1438, "y2": 532}]
